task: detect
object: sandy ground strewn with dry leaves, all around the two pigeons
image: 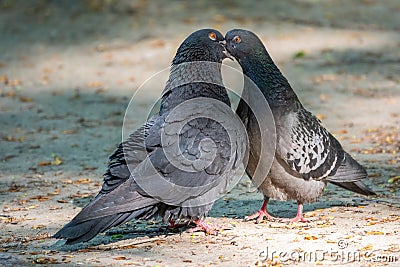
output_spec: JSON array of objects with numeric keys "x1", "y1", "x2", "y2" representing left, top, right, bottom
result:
[{"x1": 0, "y1": 0, "x2": 400, "y2": 266}]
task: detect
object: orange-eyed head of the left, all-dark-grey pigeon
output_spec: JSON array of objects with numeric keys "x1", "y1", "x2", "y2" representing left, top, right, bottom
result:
[{"x1": 172, "y1": 29, "x2": 227, "y2": 65}]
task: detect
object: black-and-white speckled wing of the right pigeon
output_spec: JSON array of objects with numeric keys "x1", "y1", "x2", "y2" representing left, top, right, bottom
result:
[{"x1": 277, "y1": 109, "x2": 344, "y2": 180}]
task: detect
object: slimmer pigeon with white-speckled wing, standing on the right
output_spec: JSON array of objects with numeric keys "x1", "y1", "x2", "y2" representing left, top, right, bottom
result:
[{"x1": 225, "y1": 29, "x2": 375, "y2": 222}]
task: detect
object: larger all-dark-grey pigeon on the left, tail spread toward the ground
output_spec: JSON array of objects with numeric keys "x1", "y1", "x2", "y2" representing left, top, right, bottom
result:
[{"x1": 54, "y1": 29, "x2": 247, "y2": 244}]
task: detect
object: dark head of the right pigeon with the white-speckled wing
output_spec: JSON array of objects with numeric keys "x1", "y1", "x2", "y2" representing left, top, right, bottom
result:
[{"x1": 225, "y1": 29, "x2": 270, "y2": 67}]
